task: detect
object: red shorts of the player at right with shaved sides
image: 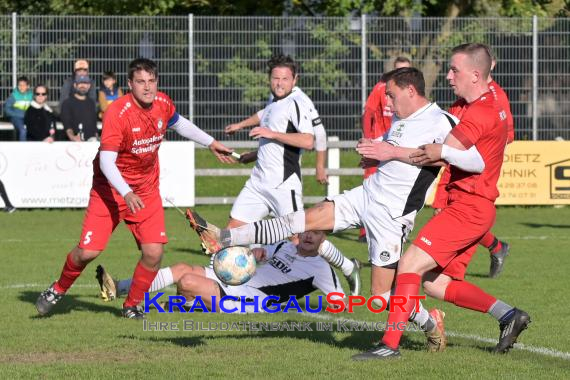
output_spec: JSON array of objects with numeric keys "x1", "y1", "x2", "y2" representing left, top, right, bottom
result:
[{"x1": 414, "y1": 191, "x2": 496, "y2": 280}]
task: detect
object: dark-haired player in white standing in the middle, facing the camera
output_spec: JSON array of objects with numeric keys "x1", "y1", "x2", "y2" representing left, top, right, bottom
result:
[{"x1": 219, "y1": 55, "x2": 360, "y2": 295}]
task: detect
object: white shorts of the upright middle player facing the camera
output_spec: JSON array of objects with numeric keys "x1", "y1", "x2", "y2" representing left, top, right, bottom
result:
[{"x1": 230, "y1": 181, "x2": 303, "y2": 223}]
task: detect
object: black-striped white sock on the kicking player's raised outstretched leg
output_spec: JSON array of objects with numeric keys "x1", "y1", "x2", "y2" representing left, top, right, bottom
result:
[{"x1": 227, "y1": 211, "x2": 305, "y2": 245}]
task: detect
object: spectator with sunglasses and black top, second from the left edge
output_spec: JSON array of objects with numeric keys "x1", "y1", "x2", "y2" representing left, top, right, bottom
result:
[{"x1": 24, "y1": 84, "x2": 55, "y2": 143}]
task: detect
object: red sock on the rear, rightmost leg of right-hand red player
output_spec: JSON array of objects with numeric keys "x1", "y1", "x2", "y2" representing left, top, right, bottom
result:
[{"x1": 444, "y1": 280, "x2": 497, "y2": 313}]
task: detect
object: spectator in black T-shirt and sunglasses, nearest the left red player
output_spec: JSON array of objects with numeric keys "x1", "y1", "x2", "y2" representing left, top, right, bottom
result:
[{"x1": 60, "y1": 75, "x2": 98, "y2": 141}]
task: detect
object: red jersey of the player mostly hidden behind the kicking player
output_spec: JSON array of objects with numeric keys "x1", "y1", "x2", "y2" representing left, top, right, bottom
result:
[{"x1": 362, "y1": 82, "x2": 392, "y2": 139}]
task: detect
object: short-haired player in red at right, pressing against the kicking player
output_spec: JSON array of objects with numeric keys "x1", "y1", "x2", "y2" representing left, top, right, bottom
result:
[{"x1": 353, "y1": 44, "x2": 530, "y2": 360}]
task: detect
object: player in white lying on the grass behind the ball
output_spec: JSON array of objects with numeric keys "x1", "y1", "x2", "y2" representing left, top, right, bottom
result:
[{"x1": 97, "y1": 231, "x2": 344, "y2": 312}]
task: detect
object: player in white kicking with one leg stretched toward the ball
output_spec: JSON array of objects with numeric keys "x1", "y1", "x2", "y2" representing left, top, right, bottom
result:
[{"x1": 186, "y1": 68, "x2": 482, "y2": 350}]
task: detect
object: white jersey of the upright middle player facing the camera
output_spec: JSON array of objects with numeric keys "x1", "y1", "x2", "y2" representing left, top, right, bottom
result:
[{"x1": 248, "y1": 90, "x2": 320, "y2": 193}]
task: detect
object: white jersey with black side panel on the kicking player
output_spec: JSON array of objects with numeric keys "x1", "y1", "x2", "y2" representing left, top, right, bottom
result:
[{"x1": 364, "y1": 103, "x2": 459, "y2": 221}]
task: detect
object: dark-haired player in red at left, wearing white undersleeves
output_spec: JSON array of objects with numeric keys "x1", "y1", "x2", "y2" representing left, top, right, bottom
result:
[{"x1": 36, "y1": 58, "x2": 233, "y2": 319}]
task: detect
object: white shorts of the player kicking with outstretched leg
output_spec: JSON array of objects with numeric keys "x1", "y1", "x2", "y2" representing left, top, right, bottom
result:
[{"x1": 327, "y1": 186, "x2": 413, "y2": 267}]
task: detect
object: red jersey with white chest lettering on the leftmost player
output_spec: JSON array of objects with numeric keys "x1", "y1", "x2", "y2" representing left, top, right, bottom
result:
[{"x1": 93, "y1": 92, "x2": 176, "y2": 196}]
